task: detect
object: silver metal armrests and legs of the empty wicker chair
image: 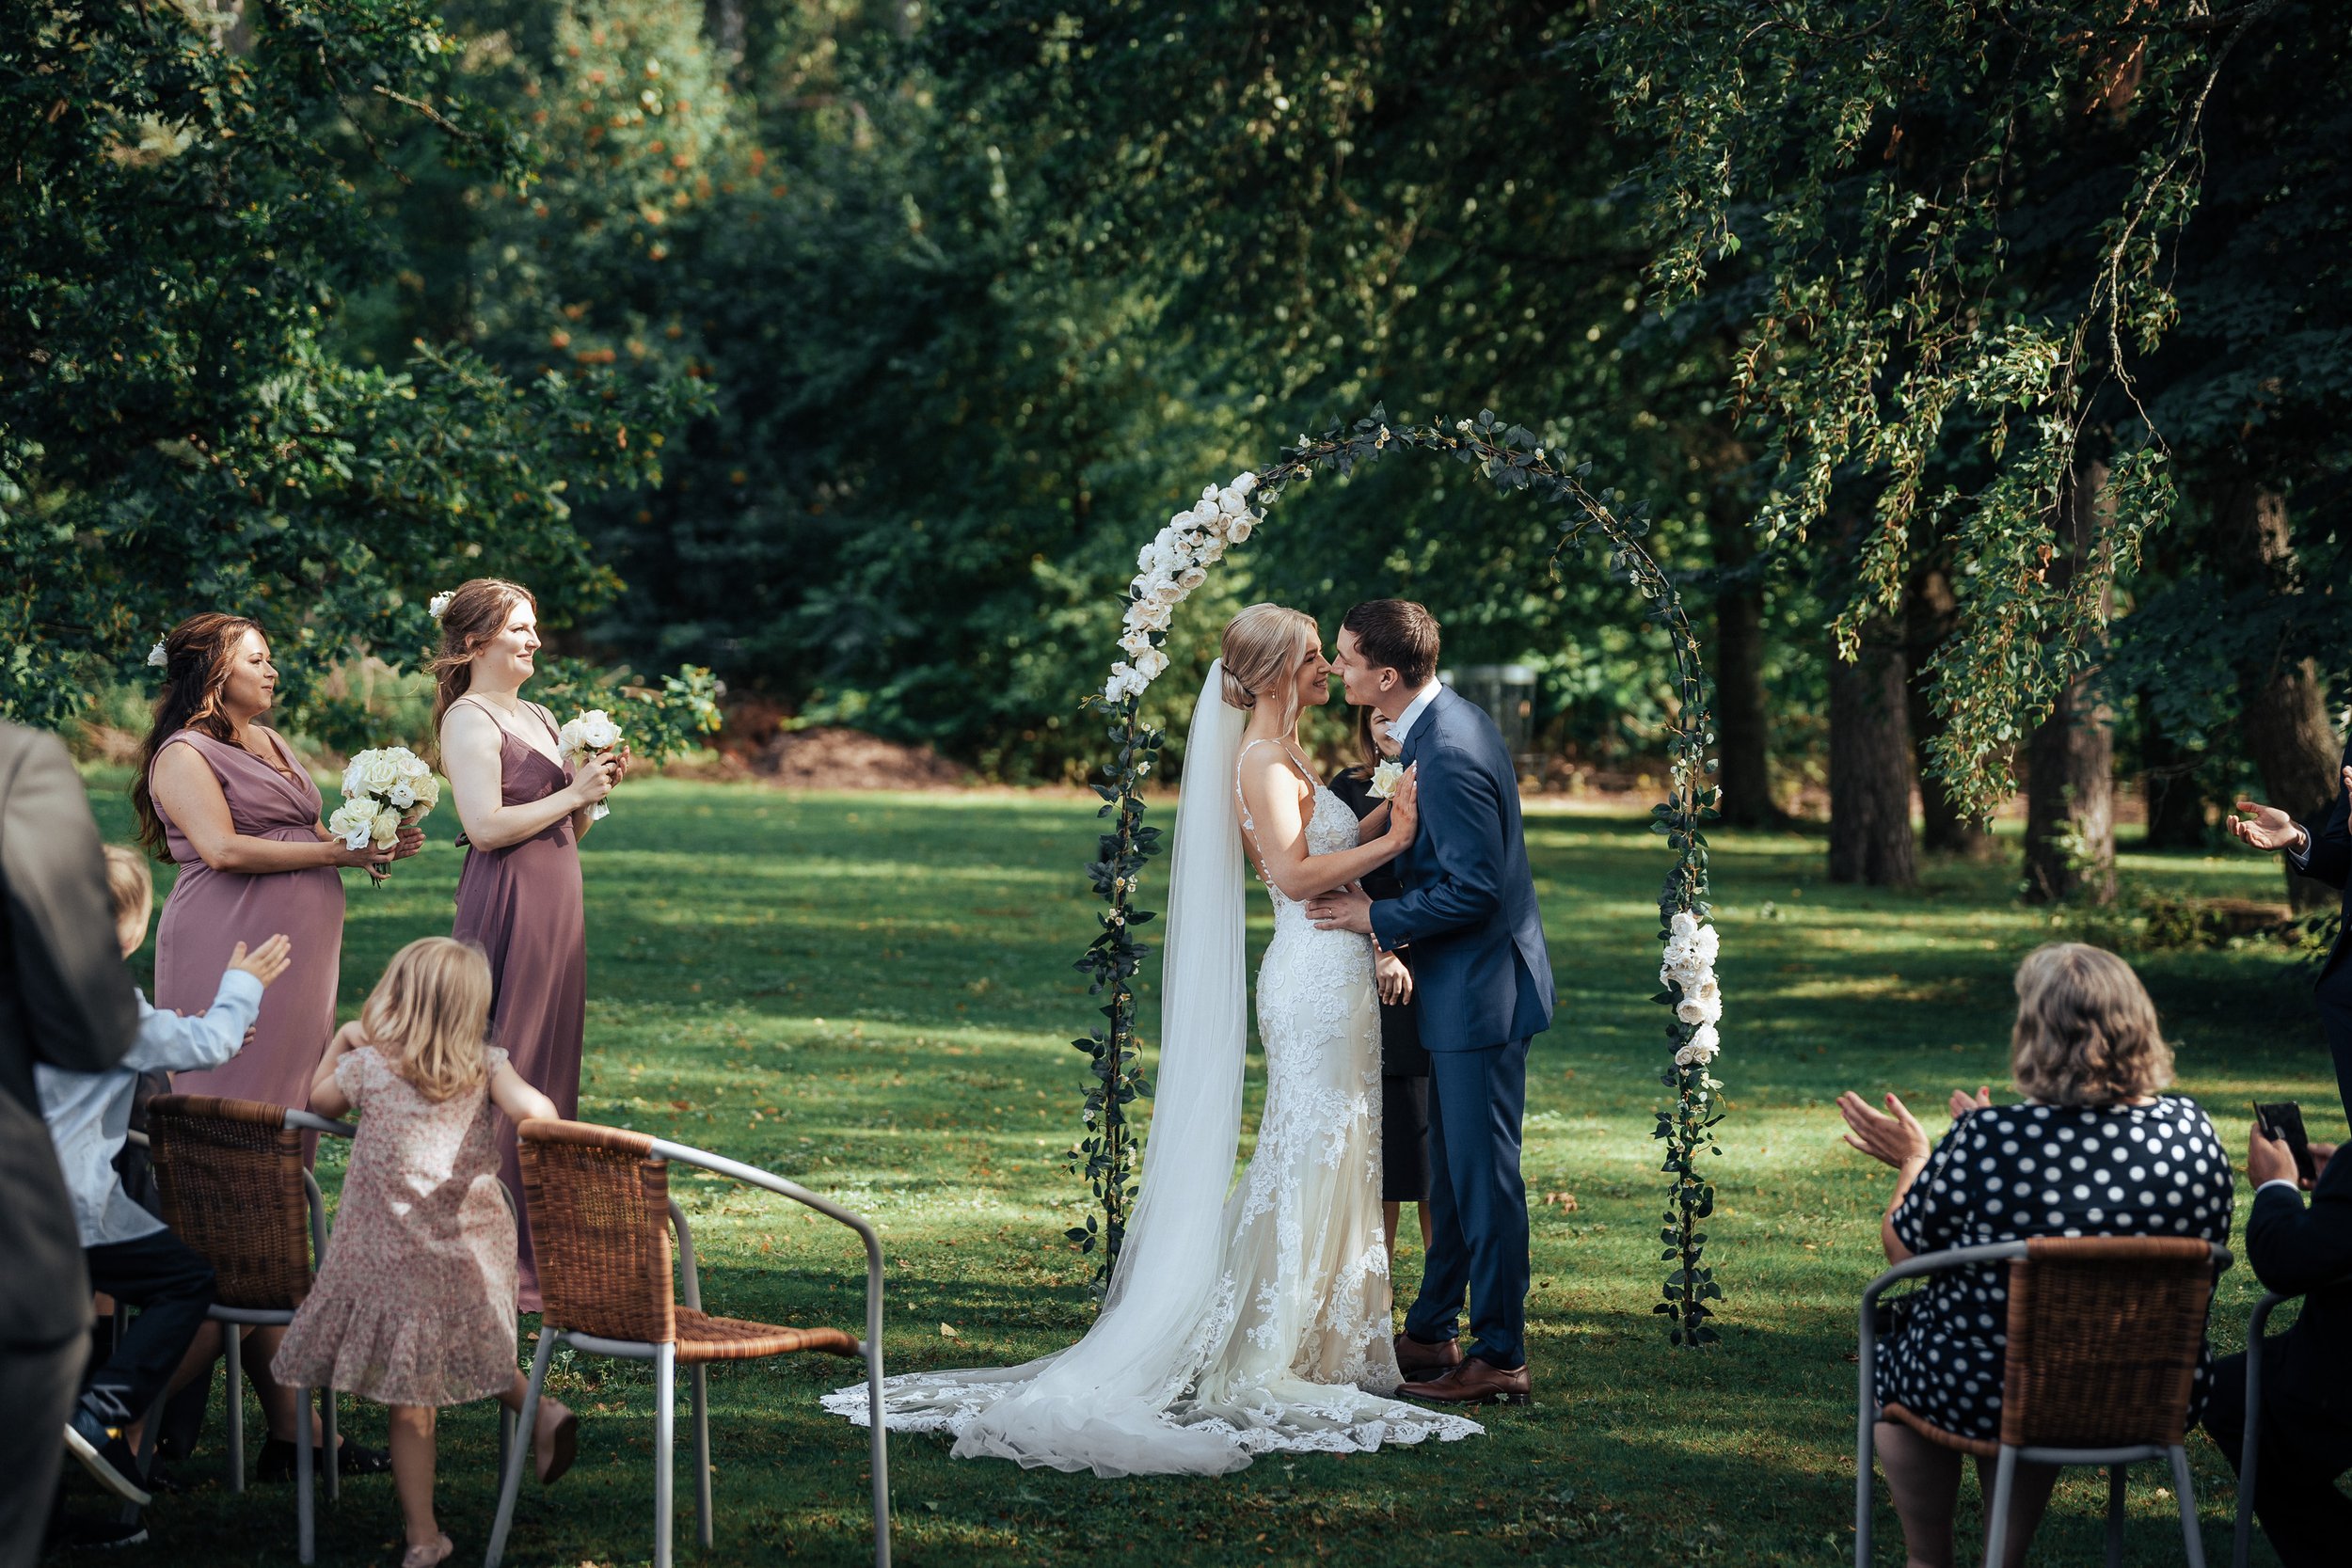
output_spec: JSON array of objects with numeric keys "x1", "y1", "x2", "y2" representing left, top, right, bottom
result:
[{"x1": 483, "y1": 1138, "x2": 889, "y2": 1568}]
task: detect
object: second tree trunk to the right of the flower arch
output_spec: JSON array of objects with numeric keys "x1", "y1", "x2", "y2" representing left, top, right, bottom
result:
[{"x1": 1830, "y1": 623, "x2": 1917, "y2": 886}]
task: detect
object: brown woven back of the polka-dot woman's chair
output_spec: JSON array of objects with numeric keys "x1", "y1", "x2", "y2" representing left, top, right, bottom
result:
[{"x1": 2002, "y1": 1237, "x2": 2214, "y2": 1449}]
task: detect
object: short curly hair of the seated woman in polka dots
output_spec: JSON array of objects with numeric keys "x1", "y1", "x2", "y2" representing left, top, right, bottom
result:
[{"x1": 2009, "y1": 942, "x2": 2173, "y2": 1105}]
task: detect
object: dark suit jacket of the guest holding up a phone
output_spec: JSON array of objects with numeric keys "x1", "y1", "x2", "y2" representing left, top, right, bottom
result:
[{"x1": 2247, "y1": 1145, "x2": 2352, "y2": 1427}]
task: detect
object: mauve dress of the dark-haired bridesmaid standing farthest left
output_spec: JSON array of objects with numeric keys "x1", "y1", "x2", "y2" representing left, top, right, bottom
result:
[{"x1": 151, "y1": 729, "x2": 343, "y2": 1107}]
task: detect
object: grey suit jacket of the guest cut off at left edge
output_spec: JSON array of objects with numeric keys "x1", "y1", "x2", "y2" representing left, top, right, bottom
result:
[{"x1": 0, "y1": 724, "x2": 139, "y2": 1347}]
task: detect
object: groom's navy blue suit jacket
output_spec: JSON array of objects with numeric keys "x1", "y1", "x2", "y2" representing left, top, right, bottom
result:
[{"x1": 1372, "y1": 689, "x2": 1552, "y2": 1051}]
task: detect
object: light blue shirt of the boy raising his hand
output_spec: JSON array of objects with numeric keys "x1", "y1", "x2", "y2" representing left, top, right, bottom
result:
[{"x1": 33, "y1": 969, "x2": 262, "y2": 1246}]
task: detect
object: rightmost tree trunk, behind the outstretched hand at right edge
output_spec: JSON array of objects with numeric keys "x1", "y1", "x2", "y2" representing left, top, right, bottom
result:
[{"x1": 2216, "y1": 482, "x2": 2341, "y2": 910}]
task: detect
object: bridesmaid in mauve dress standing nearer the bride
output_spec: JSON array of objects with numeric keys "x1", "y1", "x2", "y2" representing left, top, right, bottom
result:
[{"x1": 433, "y1": 578, "x2": 628, "y2": 1312}]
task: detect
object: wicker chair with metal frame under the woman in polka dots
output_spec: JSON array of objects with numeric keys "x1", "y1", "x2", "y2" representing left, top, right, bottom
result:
[{"x1": 1853, "y1": 1237, "x2": 2230, "y2": 1568}]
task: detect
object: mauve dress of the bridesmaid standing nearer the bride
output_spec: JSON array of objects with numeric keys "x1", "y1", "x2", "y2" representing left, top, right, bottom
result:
[{"x1": 452, "y1": 703, "x2": 588, "y2": 1312}]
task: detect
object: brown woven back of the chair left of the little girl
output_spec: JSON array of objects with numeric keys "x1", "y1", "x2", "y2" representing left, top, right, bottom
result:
[{"x1": 149, "y1": 1096, "x2": 310, "y2": 1312}]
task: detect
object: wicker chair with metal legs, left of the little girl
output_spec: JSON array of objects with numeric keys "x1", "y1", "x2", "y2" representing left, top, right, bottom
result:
[{"x1": 149, "y1": 1096, "x2": 353, "y2": 1563}]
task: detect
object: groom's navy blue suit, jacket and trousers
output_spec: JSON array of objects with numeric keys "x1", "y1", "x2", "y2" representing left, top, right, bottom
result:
[{"x1": 1372, "y1": 689, "x2": 1552, "y2": 1369}]
